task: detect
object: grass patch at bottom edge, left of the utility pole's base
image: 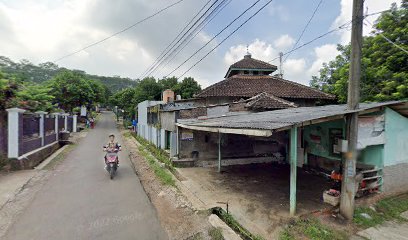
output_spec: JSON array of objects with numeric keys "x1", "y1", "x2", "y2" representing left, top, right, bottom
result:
[{"x1": 279, "y1": 218, "x2": 348, "y2": 240}]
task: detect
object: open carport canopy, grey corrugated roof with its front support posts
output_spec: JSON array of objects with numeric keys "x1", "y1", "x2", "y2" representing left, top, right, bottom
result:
[{"x1": 177, "y1": 101, "x2": 408, "y2": 216}]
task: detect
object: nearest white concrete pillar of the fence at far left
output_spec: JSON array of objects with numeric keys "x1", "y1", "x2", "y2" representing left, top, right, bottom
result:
[{"x1": 6, "y1": 108, "x2": 25, "y2": 158}]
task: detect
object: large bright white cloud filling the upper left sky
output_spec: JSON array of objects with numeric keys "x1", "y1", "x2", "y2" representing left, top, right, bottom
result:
[{"x1": 0, "y1": 0, "x2": 222, "y2": 85}]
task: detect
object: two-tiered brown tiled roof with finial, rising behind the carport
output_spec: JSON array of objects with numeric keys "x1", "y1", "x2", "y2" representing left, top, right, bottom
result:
[{"x1": 196, "y1": 54, "x2": 335, "y2": 109}]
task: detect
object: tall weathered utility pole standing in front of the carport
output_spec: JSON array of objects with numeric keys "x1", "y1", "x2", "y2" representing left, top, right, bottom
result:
[{"x1": 340, "y1": 0, "x2": 364, "y2": 220}]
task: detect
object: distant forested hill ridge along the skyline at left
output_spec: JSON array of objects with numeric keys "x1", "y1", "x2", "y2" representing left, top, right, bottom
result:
[{"x1": 0, "y1": 56, "x2": 137, "y2": 92}]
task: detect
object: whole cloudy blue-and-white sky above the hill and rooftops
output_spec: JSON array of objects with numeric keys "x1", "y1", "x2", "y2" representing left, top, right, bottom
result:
[{"x1": 0, "y1": 0, "x2": 399, "y2": 87}]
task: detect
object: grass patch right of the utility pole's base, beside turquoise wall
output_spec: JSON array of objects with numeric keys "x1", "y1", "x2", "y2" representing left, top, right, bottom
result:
[{"x1": 353, "y1": 194, "x2": 408, "y2": 228}]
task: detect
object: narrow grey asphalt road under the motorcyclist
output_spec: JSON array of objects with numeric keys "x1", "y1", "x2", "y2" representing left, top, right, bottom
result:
[{"x1": 5, "y1": 112, "x2": 167, "y2": 240}]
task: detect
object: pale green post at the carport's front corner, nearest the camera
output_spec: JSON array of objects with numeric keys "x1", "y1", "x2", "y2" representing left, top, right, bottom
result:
[{"x1": 290, "y1": 126, "x2": 298, "y2": 216}]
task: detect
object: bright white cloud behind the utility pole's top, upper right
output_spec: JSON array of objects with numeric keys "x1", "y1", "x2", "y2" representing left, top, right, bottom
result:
[{"x1": 332, "y1": 0, "x2": 399, "y2": 44}]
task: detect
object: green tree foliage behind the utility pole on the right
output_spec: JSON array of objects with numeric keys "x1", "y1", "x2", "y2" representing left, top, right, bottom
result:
[{"x1": 310, "y1": 0, "x2": 408, "y2": 103}]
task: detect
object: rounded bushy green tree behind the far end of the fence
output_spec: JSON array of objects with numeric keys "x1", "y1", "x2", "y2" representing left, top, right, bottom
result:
[{"x1": 49, "y1": 71, "x2": 95, "y2": 112}]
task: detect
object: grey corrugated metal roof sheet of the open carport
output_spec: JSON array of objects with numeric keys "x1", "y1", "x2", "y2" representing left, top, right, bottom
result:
[{"x1": 178, "y1": 101, "x2": 408, "y2": 130}]
